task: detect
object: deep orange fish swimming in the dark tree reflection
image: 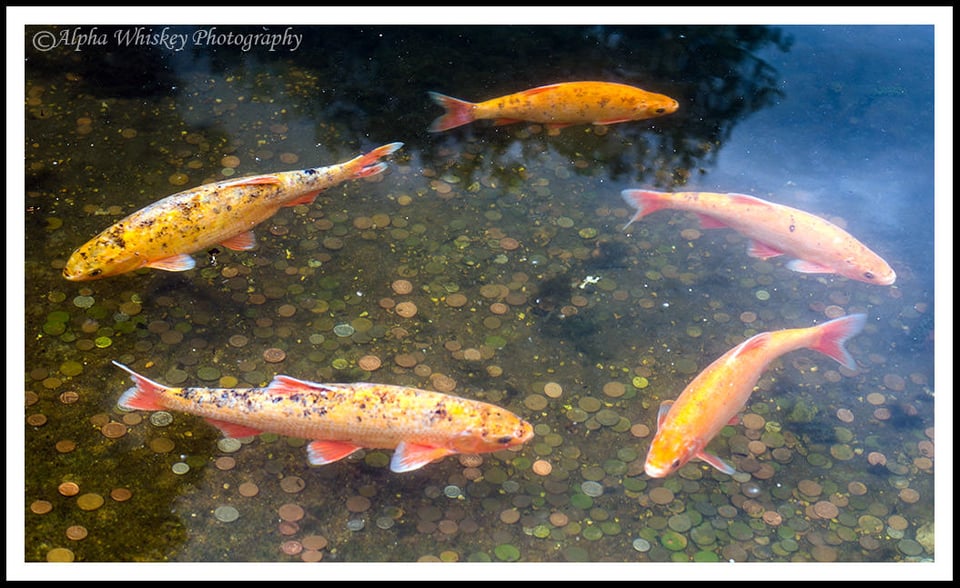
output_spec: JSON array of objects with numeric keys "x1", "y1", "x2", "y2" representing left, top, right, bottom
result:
[{"x1": 429, "y1": 82, "x2": 680, "y2": 133}]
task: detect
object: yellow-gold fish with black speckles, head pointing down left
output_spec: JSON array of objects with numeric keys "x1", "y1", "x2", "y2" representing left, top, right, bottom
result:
[{"x1": 63, "y1": 143, "x2": 403, "y2": 281}]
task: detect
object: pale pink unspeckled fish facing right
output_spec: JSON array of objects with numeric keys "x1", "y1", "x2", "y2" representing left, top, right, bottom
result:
[{"x1": 621, "y1": 190, "x2": 897, "y2": 286}]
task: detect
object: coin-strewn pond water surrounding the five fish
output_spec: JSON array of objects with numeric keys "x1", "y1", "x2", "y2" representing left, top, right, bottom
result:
[{"x1": 8, "y1": 8, "x2": 949, "y2": 584}]
